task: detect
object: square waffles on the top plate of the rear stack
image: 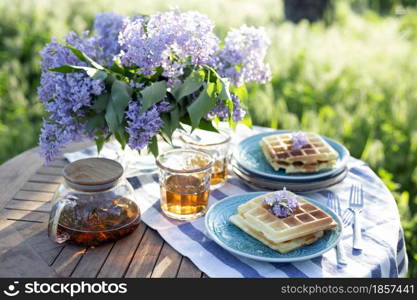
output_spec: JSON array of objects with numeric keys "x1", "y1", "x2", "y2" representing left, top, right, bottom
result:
[{"x1": 260, "y1": 133, "x2": 338, "y2": 174}]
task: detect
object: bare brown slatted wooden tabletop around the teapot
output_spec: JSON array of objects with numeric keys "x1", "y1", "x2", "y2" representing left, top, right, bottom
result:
[{"x1": 0, "y1": 141, "x2": 207, "y2": 278}]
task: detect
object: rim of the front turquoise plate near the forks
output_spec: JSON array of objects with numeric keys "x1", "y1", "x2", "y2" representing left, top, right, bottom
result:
[{"x1": 204, "y1": 191, "x2": 343, "y2": 263}]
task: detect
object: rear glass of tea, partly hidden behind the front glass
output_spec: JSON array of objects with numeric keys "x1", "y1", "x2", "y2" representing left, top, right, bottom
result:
[{"x1": 180, "y1": 130, "x2": 231, "y2": 190}]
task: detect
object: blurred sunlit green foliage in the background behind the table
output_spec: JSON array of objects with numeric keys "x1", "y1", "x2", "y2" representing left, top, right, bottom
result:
[{"x1": 0, "y1": 0, "x2": 417, "y2": 277}]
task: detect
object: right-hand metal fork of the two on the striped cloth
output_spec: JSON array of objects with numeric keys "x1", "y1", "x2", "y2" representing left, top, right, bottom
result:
[{"x1": 349, "y1": 185, "x2": 363, "y2": 250}]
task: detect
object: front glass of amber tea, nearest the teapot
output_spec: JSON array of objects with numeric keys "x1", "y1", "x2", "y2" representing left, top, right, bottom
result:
[{"x1": 156, "y1": 149, "x2": 214, "y2": 220}]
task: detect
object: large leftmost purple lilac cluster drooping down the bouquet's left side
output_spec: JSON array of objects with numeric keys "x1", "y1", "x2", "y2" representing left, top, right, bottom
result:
[{"x1": 38, "y1": 33, "x2": 104, "y2": 163}]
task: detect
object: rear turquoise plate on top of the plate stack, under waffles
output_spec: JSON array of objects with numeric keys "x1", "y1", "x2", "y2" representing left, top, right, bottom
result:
[{"x1": 233, "y1": 130, "x2": 349, "y2": 182}]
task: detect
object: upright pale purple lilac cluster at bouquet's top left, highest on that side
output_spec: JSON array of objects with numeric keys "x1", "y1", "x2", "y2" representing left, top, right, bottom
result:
[{"x1": 94, "y1": 12, "x2": 124, "y2": 66}]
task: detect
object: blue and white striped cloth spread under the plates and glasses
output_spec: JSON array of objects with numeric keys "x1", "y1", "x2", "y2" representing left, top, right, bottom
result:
[{"x1": 66, "y1": 127, "x2": 408, "y2": 277}]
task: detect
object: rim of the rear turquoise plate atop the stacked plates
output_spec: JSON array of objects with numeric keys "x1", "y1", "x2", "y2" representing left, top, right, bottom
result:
[{"x1": 233, "y1": 129, "x2": 350, "y2": 182}]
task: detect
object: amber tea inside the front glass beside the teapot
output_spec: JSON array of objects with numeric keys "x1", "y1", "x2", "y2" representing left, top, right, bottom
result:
[{"x1": 161, "y1": 175, "x2": 209, "y2": 216}]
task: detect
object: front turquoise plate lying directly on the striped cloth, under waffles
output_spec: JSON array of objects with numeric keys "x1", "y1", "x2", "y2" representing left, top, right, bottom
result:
[{"x1": 205, "y1": 192, "x2": 342, "y2": 262}]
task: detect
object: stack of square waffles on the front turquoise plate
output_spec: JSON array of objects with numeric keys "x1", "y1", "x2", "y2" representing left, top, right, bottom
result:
[{"x1": 230, "y1": 191, "x2": 337, "y2": 253}]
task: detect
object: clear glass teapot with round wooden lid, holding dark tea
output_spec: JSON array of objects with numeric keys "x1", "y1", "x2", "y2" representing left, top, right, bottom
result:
[{"x1": 48, "y1": 158, "x2": 140, "y2": 246}]
